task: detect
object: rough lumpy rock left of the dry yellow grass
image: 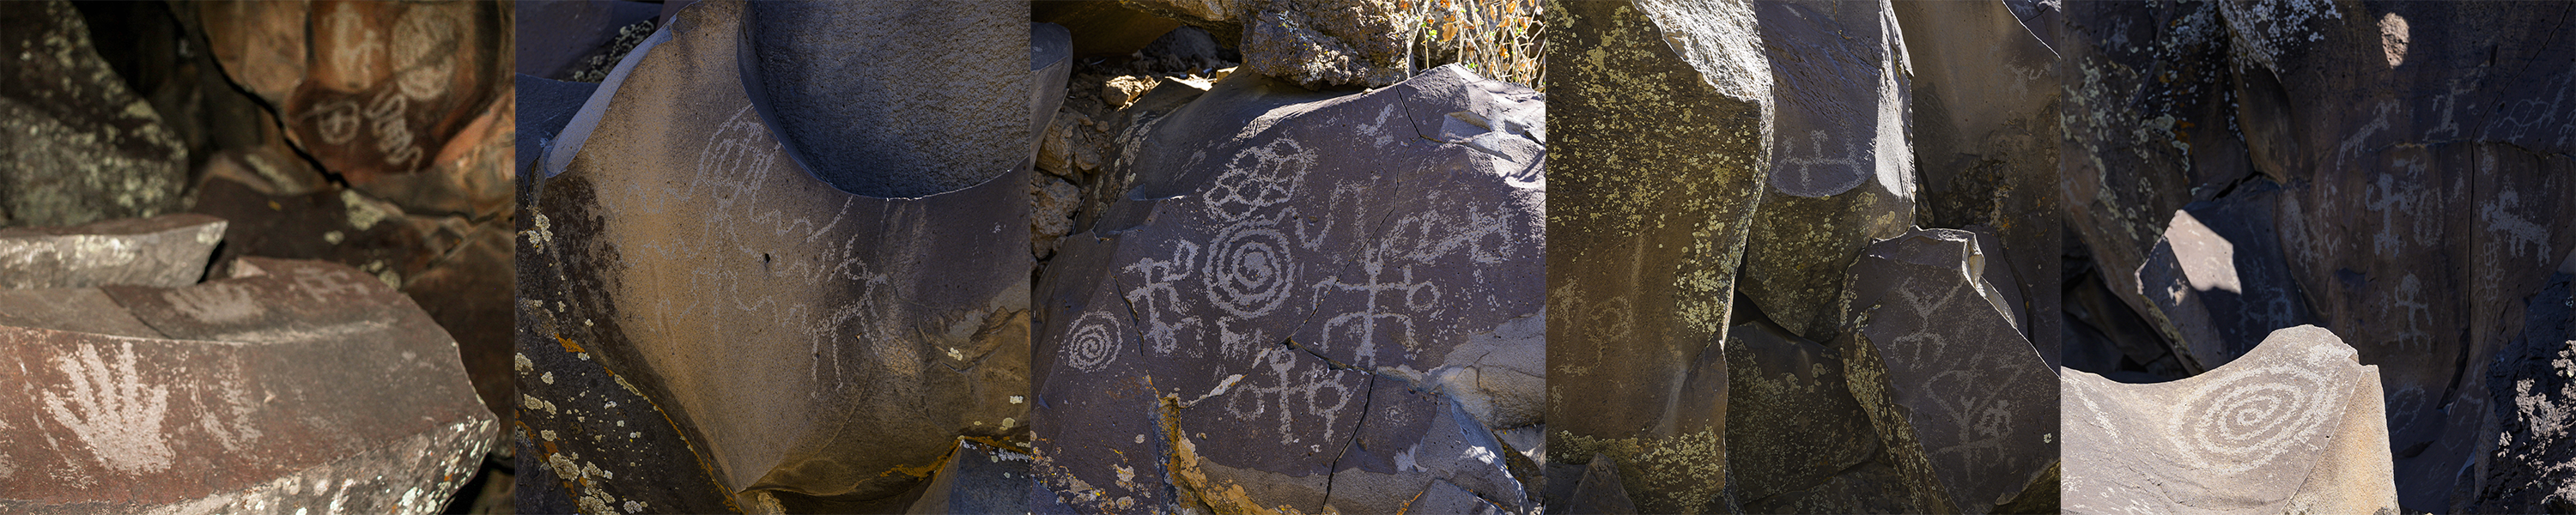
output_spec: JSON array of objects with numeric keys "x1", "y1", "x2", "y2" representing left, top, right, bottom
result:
[{"x1": 1123, "y1": 0, "x2": 1417, "y2": 90}]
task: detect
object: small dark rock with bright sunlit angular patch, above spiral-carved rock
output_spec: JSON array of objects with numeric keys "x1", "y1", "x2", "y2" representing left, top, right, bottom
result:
[{"x1": 2138, "y1": 183, "x2": 2316, "y2": 368}]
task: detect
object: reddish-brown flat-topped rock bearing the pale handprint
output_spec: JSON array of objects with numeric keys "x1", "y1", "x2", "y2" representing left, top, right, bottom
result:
[{"x1": 0, "y1": 258, "x2": 495, "y2": 512}]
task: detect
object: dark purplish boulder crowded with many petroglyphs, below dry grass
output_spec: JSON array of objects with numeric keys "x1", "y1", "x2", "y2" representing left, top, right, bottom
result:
[{"x1": 1033, "y1": 67, "x2": 1546, "y2": 512}]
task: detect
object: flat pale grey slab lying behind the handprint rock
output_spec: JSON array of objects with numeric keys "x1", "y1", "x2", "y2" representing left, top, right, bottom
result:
[{"x1": 0, "y1": 214, "x2": 224, "y2": 288}]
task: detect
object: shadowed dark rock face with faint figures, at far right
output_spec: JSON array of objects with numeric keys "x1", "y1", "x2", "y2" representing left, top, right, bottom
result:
[{"x1": 2223, "y1": 3, "x2": 2576, "y2": 510}]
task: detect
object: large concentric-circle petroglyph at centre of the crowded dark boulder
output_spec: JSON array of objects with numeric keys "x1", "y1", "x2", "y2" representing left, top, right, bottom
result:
[{"x1": 1206, "y1": 224, "x2": 1296, "y2": 317}]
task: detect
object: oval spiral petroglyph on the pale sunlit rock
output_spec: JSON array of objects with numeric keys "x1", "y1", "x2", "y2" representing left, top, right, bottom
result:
[{"x1": 2166, "y1": 360, "x2": 2349, "y2": 474}]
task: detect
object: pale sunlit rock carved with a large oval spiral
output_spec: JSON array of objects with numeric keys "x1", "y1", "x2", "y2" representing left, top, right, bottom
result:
[{"x1": 2061, "y1": 324, "x2": 2398, "y2": 512}]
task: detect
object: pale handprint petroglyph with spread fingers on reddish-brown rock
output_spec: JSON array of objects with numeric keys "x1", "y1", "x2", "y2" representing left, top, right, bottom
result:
[{"x1": 44, "y1": 342, "x2": 173, "y2": 474}]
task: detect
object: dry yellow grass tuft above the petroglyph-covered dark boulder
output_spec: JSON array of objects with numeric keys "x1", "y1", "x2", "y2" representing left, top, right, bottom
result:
[{"x1": 1399, "y1": 0, "x2": 1548, "y2": 90}]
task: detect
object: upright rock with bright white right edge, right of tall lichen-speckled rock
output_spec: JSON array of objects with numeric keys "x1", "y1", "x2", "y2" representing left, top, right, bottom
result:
[{"x1": 1741, "y1": 3, "x2": 1917, "y2": 340}]
